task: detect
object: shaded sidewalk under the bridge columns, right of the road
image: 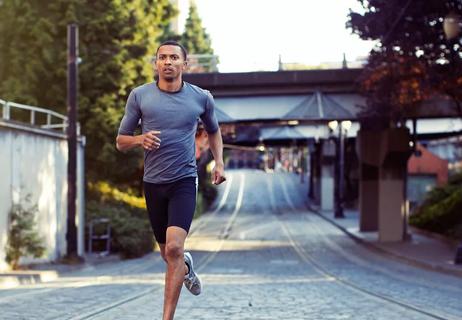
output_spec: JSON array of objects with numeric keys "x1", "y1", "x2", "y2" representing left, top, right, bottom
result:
[{"x1": 313, "y1": 210, "x2": 462, "y2": 277}]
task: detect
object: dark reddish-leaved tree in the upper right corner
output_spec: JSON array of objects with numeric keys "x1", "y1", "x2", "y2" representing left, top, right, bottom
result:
[{"x1": 347, "y1": 0, "x2": 462, "y2": 120}]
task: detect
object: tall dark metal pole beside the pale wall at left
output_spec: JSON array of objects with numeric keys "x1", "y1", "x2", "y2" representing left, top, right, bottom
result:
[{"x1": 66, "y1": 24, "x2": 78, "y2": 258}]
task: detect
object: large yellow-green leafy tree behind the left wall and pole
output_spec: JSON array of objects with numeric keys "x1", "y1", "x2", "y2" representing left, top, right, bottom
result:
[{"x1": 0, "y1": 0, "x2": 175, "y2": 188}]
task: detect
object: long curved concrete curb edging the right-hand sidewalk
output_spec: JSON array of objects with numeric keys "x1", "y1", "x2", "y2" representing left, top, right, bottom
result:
[{"x1": 307, "y1": 205, "x2": 462, "y2": 277}]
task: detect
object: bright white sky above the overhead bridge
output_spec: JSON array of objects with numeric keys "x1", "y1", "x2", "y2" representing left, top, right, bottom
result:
[{"x1": 175, "y1": 0, "x2": 373, "y2": 72}]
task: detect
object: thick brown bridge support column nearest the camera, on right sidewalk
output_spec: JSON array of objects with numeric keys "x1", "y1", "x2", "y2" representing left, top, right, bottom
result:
[{"x1": 356, "y1": 128, "x2": 411, "y2": 242}]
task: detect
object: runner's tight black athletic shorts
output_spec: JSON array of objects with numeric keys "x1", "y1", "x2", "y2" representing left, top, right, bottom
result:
[{"x1": 144, "y1": 177, "x2": 197, "y2": 244}]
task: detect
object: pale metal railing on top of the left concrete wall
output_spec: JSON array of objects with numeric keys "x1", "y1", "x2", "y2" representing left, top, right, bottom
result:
[{"x1": 0, "y1": 99, "x2": 80, "y2": 135}]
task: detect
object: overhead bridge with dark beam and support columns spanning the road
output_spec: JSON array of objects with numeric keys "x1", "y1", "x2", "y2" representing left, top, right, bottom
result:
[{"x1": 184, "y1": 69, "x2": 462, "y2": 241}]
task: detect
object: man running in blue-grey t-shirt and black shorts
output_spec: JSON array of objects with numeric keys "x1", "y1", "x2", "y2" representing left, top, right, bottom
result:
[{"x1": 117, "y1": 41, "x2": 225, "y2": 320}]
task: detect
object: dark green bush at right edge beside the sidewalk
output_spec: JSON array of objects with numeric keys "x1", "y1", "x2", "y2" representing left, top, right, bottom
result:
[{"x1": 409, "y1": 173, "x2": 462, "y2": 239}]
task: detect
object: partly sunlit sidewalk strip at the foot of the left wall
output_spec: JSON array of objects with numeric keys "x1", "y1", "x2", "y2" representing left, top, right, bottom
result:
[{"x1": 0, "y1": 254, "x2": 120, "y2": 290}]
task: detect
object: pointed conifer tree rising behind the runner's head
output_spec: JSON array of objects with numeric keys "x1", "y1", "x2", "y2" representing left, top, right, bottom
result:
[{"x1": 181, "y1": 1, "x2": 213, "y2": 54}]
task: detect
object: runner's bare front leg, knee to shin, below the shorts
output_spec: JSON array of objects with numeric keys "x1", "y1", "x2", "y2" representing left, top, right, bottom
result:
[{"x1": 160, "y1": 226, "x2": 188, "y2": 320}]
